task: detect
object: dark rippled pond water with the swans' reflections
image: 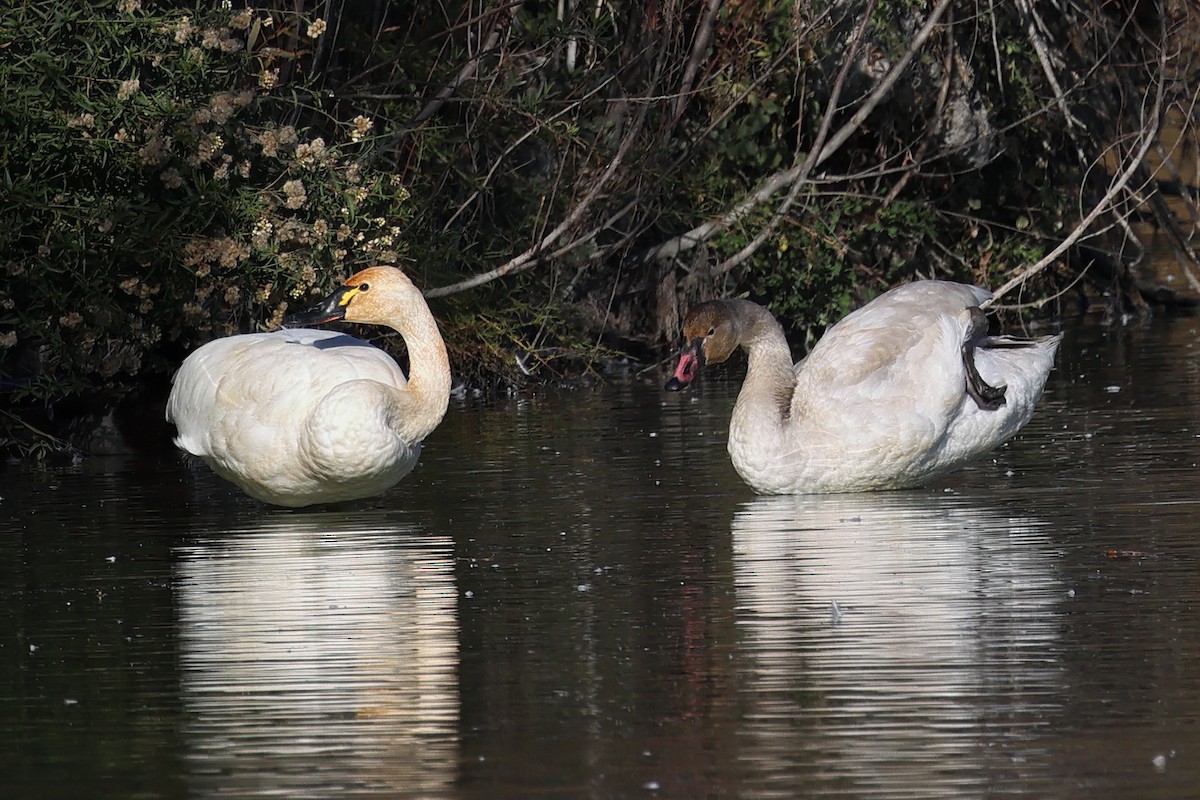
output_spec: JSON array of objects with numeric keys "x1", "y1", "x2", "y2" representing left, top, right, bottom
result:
[{"x1": 0, "y1": 319, "x2": 1200, "y2": 800}]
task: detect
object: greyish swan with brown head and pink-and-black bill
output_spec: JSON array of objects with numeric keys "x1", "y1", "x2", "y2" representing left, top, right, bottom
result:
[{"x1": 666, "y1": 281, "x2": 1062, "y2": 494}]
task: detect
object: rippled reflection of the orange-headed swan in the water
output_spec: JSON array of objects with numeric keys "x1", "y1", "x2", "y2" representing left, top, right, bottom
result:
[{"x1": 178, "y1": 515, "x2": 458, "y2": 798}]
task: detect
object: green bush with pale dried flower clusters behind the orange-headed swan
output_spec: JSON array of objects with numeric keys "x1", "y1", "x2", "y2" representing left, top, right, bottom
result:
[{"x1": 0, "y1": 0, "x2": 410, "y2": 401}]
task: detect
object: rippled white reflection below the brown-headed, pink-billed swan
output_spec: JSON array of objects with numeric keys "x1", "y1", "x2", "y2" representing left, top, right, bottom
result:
[{"x1": 733, "y1": 493, "x2": 1064, "y2": 799}]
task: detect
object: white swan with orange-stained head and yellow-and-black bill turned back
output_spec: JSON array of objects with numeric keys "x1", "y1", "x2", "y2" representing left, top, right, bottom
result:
[{"x1": 167, "y1": 266, "x2": 450, "y2": 507}]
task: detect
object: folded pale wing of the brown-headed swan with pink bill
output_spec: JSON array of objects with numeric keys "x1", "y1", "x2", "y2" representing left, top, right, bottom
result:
[{"x1": 792, "y1": 281, "x2": 1032, "y2": 485}]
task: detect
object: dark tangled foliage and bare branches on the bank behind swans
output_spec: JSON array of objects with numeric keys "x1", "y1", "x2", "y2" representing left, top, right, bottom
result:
[{"x1": 0, "y1": 0, "x2": 1200, "y2": 453}]
